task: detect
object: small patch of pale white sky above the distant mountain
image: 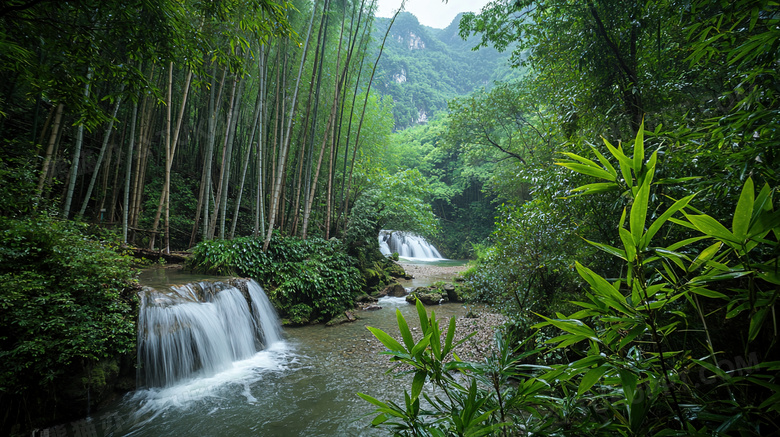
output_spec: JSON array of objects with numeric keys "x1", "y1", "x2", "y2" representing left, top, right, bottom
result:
[{"x1": 376, "y1": 0, "x2": 490, "y2": 29}]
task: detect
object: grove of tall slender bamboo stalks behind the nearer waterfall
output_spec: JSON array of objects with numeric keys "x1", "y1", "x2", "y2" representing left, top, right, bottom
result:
[{"x1": 0, "y1": 0, "x2": 400, "y2": 251}]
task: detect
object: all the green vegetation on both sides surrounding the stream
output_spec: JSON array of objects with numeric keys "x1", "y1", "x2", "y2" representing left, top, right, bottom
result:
[{"x1": 0, "y1": 0, "x2": 780, "y2": 435}]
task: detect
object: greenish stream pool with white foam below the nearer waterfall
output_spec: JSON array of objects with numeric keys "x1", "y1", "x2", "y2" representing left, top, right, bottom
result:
[{"x1": 58, "y1": 262, "x2": 476, "y2": 437}]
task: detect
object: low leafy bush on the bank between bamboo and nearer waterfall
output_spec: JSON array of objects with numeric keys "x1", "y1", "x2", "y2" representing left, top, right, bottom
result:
[{"x1": 189, "y1": 234, "x2": 362, "y2": 324}]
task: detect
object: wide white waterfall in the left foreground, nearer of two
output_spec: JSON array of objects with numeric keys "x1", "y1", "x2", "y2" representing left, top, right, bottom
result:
[{"x1": 138, "y1": 279, "x2": 282, "y2": 387}]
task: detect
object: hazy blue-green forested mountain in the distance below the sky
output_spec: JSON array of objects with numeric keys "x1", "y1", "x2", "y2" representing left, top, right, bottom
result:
[{"x1": 374, "y1": 12, "x2": 517, "y2": 130}]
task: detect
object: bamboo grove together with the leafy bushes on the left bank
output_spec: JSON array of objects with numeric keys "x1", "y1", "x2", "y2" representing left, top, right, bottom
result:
[{"x1": 0, "y1": 0, "x2": 444, "y2": 434}]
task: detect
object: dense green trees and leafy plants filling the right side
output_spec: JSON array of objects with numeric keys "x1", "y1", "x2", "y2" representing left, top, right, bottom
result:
[{"x1": 362, "y1": 0, "x2": 780, "y2": 436}]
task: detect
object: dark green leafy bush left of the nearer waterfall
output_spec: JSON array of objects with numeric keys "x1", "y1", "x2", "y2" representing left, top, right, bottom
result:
[{"x1": 0, "y1": 216, "x2": 136, "y2": 432}]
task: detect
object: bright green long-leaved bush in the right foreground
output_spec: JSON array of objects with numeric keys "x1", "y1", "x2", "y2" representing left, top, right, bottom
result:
[{"x1": 360, "y1": 129, "x2": 780, "y2": 436}]
